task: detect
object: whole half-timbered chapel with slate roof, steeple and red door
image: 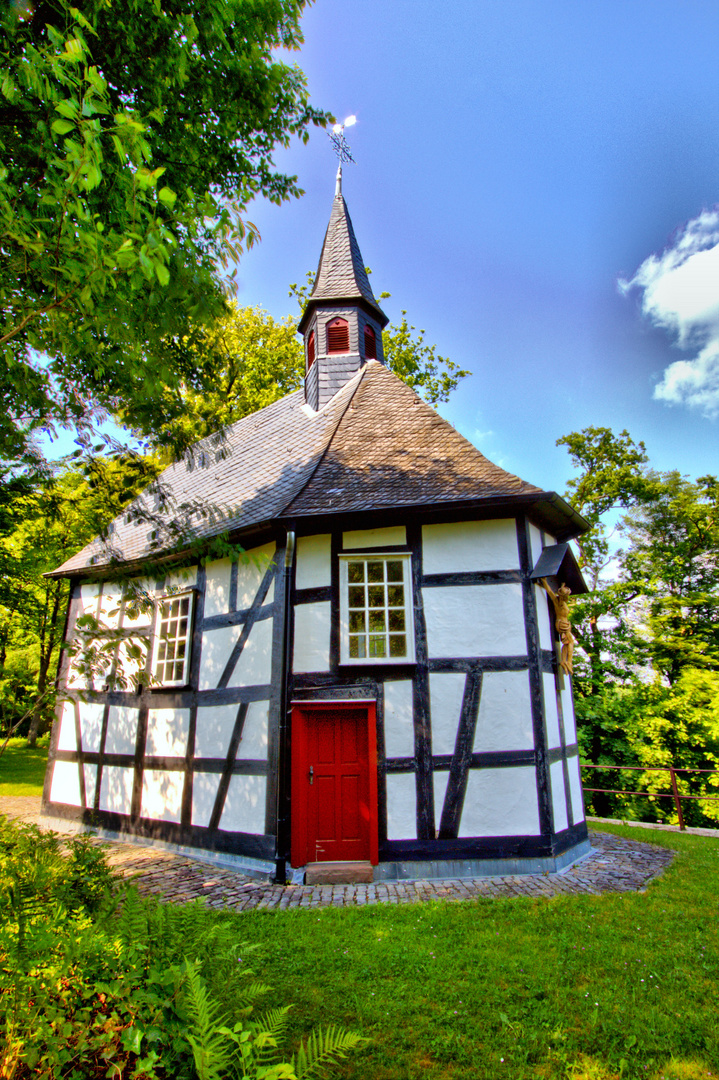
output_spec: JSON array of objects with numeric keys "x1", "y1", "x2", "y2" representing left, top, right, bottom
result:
[{"x1": 43, "y1": 166, "x2": 588, "y2": 881}]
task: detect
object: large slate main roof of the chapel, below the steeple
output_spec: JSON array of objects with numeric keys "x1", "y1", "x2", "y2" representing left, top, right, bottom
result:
[{"x1": 53, "y1": 361, "x2": 583, "y2": 576}]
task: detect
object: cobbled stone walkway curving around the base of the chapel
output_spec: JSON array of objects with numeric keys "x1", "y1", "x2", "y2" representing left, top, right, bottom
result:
[{"x1": 0, "y1": 798, "x2": 674, "y2": 912}]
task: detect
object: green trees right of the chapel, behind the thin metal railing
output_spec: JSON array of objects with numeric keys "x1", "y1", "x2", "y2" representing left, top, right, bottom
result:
[{"x1": 559, "y1": 428, "x2": 719, "y2": 824}]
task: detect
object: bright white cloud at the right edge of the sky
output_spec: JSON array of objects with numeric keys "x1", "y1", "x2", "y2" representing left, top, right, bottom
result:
[{"x1": 619, "y1": 206, "x2": 719, "y2": 417}]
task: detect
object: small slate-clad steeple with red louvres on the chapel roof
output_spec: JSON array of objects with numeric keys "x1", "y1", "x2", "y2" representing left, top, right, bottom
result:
[{"x1": 298, "y1": 181, "x2": 389, "y2": 409}]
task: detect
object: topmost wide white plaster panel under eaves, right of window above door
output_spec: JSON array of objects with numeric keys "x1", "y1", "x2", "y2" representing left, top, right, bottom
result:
[{"x1": 422, "y1": 518, "x2": 519, "y2": 573}]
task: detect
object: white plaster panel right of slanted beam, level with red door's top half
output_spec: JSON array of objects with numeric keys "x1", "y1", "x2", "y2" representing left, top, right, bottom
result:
[{"x1": 474, "y1": 672, "x2": 534, "y2": 753}]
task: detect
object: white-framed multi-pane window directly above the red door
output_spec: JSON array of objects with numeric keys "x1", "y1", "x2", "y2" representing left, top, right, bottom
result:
[{"x1": 340, "y1": 552, "x2": 415, "y2": 664}]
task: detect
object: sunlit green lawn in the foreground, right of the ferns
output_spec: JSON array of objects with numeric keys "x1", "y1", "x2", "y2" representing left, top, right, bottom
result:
[{"x1": 225, "y1": 826, "x2": 719, "y2": 1080}]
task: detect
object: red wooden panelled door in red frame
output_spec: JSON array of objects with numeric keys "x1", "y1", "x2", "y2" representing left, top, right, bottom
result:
[{"x1": 291, "y1": 702, "x2": 377, "y2": 866}]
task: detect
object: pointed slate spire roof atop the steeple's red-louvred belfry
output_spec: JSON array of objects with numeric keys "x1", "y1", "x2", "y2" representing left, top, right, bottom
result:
[{"x1": 299, "y1": 192, "x2": 389, "y2": 333}]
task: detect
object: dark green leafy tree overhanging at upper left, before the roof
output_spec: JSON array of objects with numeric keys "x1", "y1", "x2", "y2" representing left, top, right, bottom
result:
[{"x1": 0, "y1": 0, "x2": 327, "y2": 468}]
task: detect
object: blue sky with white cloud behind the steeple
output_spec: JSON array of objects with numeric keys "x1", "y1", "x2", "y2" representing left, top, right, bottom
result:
[{"x1": 231, "y1": 0, "x2": 719, "y2": 491}]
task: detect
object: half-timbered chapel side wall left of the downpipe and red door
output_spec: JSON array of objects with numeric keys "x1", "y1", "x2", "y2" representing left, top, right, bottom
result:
[{"x1": 46, "y1": 543, "x2": 283, "y2": 859}]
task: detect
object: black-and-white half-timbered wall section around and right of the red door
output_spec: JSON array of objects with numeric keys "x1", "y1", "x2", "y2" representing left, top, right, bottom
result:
[{"x1": 291, "y1": 517, "x2": 584, "y2": 860}]
